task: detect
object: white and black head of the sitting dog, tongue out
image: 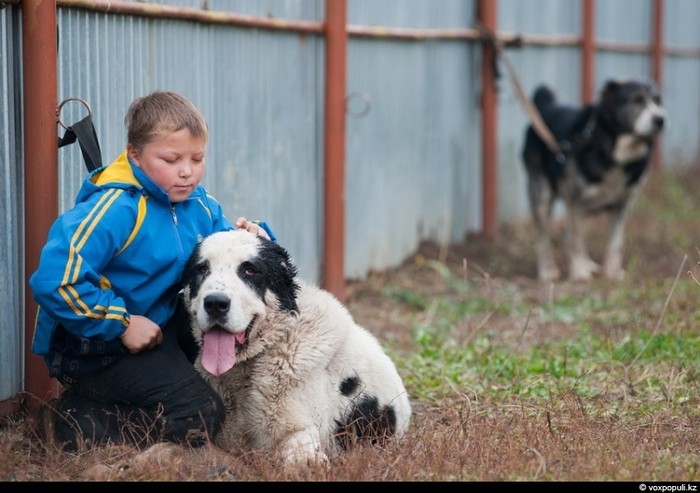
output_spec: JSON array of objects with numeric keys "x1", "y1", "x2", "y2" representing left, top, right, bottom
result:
[{"x1": 183, "y1": 229, "x2": 299, "y2": 376}]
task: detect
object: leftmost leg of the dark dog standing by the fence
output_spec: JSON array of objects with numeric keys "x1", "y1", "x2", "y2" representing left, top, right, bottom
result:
[{"x1": 528, "y1": 172, "x2": 560, "y2": 281}]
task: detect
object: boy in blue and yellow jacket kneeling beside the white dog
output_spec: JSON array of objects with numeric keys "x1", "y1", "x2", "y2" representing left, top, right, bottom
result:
[{"x1": 29, "y1": 92, "x2": 269, "y2": 450}]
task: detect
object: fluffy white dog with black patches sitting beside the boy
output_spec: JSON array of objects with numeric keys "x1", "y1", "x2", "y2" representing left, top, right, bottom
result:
[{"x1": 182, "y1": 230, "x2": 411, "y2": 464}]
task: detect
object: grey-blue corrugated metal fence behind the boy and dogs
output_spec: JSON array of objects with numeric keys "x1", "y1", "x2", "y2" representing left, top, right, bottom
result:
[{"x1": 0, "y1": 0, "x2": 700, "y2": 408}]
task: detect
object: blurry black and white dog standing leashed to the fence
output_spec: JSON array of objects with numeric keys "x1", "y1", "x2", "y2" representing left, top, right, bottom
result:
[{"x1": 522, "y1": 80, "x2": 666, "y2": 281}]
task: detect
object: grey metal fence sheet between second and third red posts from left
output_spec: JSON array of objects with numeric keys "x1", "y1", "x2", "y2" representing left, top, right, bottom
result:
[{"x1": 345, "y1": 0, "x2": 481, "y2": 279}]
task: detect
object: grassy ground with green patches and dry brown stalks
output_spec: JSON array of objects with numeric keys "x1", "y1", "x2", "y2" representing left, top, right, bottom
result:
[{"x1": 0, "y1": 167, "x2": 700, "y2": 482}]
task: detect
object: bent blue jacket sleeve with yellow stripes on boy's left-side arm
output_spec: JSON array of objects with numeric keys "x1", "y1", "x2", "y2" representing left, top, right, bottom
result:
[{"x1": 29, "y1": 189, "x2": 136, "y2": 340}]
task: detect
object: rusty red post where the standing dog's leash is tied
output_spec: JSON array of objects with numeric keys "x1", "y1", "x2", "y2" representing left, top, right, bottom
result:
[{"x1": 477, "y1": 0, "x2": 498, "y2": 239}]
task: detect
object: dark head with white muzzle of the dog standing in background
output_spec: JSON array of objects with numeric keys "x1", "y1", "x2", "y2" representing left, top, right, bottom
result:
[{"x1": 599, "y1": 80, "x2": 666, "y2": 140}]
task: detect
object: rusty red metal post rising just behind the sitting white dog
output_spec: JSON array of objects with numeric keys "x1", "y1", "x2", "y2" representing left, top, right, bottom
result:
[{"x1": 323, "y1": 0, "x2": 348, "y2": 301}]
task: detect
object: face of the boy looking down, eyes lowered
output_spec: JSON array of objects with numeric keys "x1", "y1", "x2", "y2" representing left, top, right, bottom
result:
[{"x1": 127, "y1": 129, "x2": 207, "y2": 203}]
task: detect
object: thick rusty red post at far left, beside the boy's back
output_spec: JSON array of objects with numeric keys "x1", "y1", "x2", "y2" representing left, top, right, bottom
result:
[{"x1": 22, "y1": 0, "x2": 58, "y2": 407}]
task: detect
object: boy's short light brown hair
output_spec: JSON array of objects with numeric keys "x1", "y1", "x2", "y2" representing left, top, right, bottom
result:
[{"x1": 124, "y1": 91, "x2": 209, "y2": 151}]
